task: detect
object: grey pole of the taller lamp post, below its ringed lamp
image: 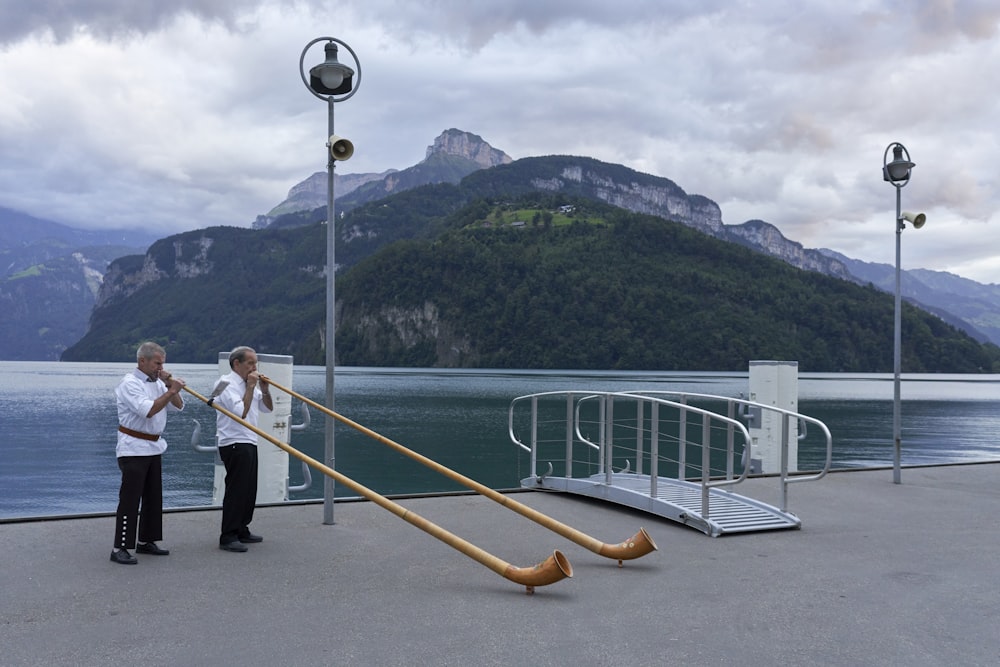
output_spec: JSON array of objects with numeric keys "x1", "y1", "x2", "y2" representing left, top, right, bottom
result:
[{"x1": 323, "y1": 95, "x2": 337, "y2": 525}]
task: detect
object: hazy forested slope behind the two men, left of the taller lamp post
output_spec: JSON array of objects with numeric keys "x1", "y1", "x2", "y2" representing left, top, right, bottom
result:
[{"x1": 62, "y1": 225, "x2": 326, "y2": 364}]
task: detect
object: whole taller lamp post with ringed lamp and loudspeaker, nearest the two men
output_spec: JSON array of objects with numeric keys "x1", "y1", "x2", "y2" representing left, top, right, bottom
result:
[{"x1": 299, "y1": 37, "x2": 361, "y2": 524}]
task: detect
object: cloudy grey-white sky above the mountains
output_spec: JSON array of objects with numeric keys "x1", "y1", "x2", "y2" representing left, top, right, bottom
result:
[{"x1": 0, "y1": 0, "x2": 1000, "y2": 283}]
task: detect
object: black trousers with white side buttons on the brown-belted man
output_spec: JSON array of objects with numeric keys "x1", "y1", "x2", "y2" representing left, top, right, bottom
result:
[{"x1": 115, "y1": 454, "x2": 163, "y2": 549}]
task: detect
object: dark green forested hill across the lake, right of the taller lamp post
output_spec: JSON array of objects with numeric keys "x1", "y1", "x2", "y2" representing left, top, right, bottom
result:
[{"x1": 337, "y1": 201, "x2": 998, "y2": 372}]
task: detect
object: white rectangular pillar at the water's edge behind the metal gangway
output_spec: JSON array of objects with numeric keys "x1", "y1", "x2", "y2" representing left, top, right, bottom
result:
[{"x1": 748, "y1": 361, "x2": 799, "y2": 474}]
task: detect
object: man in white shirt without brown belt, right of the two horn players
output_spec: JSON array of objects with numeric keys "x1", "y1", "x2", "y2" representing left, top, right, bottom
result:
[{"x1": 215, "y1": 346, "x2": 274, "y2": 552}]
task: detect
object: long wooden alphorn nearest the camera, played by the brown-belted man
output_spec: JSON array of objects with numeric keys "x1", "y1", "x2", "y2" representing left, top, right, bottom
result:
[{"x1": 184, "y1": 383, "x2": 573, "y2": 594}]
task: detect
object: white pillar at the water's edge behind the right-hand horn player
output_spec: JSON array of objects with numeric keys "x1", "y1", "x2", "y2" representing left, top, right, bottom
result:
[{"x1": 212, "y1": 352, "x2": 294, "y2": 506}]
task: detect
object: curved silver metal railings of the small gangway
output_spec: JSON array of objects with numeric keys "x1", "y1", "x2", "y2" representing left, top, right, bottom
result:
[{"x1": 508, "y1": 391, "x2": 833, "y2": 518}]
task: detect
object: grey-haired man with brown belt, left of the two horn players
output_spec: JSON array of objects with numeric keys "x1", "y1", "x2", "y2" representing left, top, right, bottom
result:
[{"x1": 111, "y1": 341, "x2": 184, "y2": 565}]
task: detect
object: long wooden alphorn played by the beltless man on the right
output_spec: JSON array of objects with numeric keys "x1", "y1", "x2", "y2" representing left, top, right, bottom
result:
[{"x1": 263, "y1": 378, "x2": 656, "y2": 567}]
